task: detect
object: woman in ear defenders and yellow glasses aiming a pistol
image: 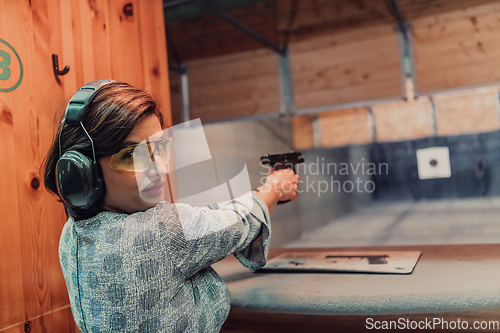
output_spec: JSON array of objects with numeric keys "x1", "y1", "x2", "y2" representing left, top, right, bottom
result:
[{"x1": 44, "y1": 81, "x2": 298, "y2": 332}]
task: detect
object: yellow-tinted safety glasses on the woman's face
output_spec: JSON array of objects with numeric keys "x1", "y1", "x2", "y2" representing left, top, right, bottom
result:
[{"x1": 110, "y1": 138, "x2": 172, "y2": 171}]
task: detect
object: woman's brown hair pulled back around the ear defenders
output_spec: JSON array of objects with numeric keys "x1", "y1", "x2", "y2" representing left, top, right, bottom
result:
[{"x1": 42, "y1": 81, "x2": 165, "y2": 220}]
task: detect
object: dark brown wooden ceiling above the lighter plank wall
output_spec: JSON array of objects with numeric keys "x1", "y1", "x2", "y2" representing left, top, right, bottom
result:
[{"x1": 166, "y1": 0, "x2": 499, "y2": 64}]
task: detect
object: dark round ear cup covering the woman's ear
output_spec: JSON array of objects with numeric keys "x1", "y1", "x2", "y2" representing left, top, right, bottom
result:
[{"x1": 56, "y1": 150, "x2": 102, "y2": 209}]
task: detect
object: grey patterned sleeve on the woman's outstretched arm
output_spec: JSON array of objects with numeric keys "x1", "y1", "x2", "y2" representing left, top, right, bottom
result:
[{"x1": 155, "y1": 192, "x2": 271, "y2": 277}]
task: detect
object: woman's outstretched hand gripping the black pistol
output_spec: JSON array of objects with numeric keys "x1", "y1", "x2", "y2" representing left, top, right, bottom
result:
[{"x1": 252, "y1": 169, "x2": 299, "y2": 214}]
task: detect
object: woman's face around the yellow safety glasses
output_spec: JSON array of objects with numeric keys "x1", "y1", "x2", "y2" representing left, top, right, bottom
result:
[{"x1": 99, "y1": 115, "x2": 167, "y2": 214}]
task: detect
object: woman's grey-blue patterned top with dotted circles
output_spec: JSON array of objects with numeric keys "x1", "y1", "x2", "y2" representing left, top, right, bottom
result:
[{"x1": 59, "y1": 193, "x2": 271, "y2": 333}]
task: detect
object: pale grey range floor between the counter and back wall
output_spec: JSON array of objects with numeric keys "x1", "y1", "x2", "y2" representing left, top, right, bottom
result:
[{"x1": 283, "y1": 197, "x2": 500, "y2": 247}]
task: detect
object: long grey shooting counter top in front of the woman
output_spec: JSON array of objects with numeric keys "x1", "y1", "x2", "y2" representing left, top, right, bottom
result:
[{"x1": 213, "y1": 244, "x2": 500, "y2": 330}]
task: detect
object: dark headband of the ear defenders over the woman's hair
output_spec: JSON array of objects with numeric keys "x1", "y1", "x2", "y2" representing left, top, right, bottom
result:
[{"x1": 64, "y1": 80, "x2": 114, "y2": 126}]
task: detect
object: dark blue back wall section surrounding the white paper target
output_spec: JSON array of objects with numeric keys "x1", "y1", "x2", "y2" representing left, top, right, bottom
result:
[{"x1": 369, "y1": 131, "x2": 500, "y2": 201}]
